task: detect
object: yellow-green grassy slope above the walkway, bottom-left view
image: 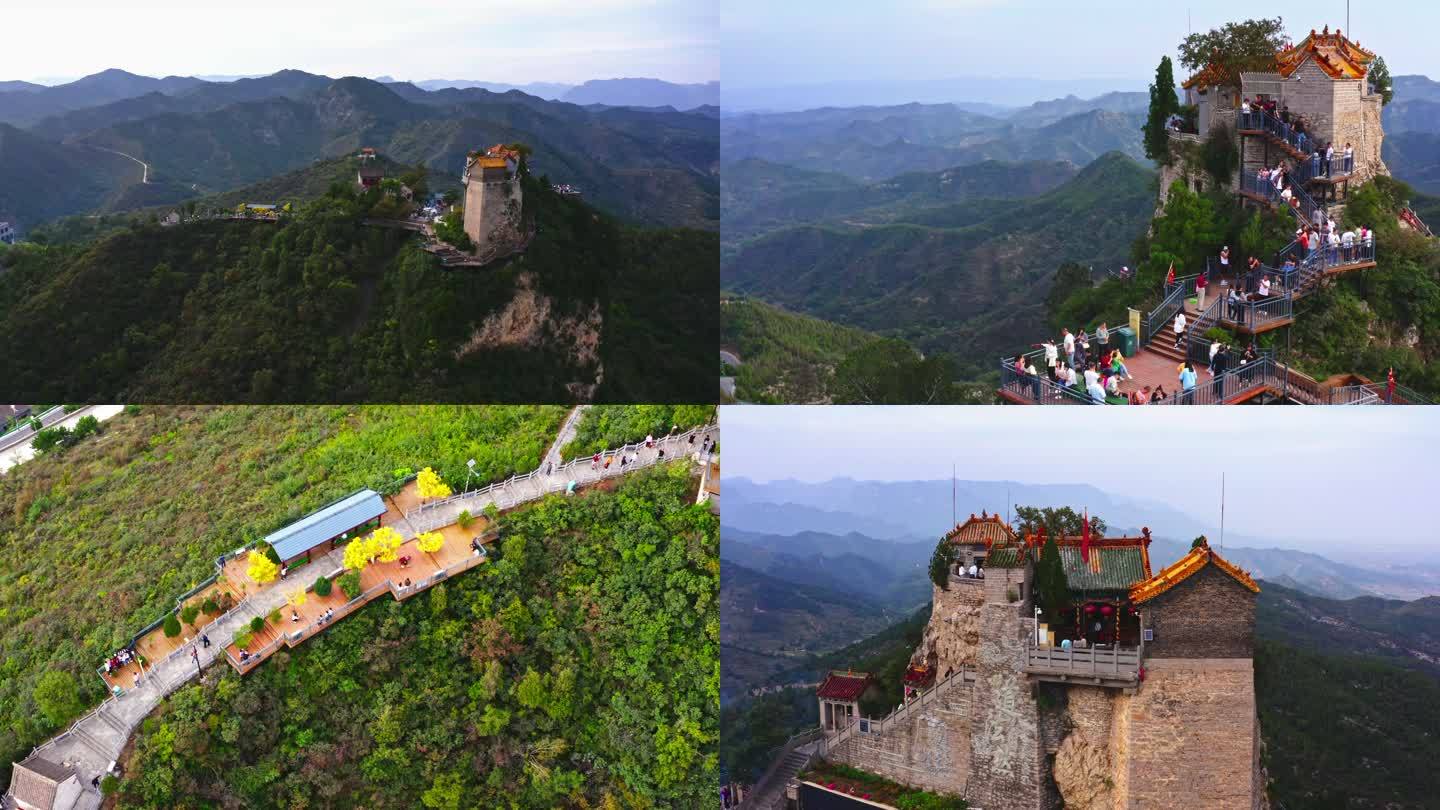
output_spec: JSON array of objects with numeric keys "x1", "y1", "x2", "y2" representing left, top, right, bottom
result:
[{"x1": 0, "y1": 406, "x2": 564, "y2": 784}]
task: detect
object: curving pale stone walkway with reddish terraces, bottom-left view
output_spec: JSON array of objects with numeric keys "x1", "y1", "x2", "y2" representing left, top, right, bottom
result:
[{"x1": 0, "y1": 408, "x2": 720, "y2": 810}]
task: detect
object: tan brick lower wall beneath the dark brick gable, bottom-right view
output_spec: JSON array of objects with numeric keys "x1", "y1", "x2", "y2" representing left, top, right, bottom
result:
[{"x1": 1116, "y1": 659, "x2": 1263, "y2": 810}]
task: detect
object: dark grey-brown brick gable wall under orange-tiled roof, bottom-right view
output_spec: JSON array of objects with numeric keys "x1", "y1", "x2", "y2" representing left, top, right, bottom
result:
[{"x1": 1140, "y1": 565, "x2": 1256, "y2": 659}]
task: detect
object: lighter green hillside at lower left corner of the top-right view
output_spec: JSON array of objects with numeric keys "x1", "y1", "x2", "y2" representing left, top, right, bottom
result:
[{"x1": 720, "y1": 297, "x2": 876, "y2": 404}]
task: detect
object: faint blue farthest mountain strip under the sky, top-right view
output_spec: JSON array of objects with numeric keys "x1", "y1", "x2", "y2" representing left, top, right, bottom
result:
[{"x1": 724, "y1": 76, "x2": 1148, "y2": 112}]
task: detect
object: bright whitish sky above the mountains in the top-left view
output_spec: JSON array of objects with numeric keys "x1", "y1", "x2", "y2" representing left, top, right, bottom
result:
[{"x1": 0, "y1": 0, "x2": 720, "y2": 84}]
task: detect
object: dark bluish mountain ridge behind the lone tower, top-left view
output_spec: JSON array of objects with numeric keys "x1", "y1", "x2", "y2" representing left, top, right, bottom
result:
[{"x1": 0, "y1": 71, "x2": 719, "y2": 229}]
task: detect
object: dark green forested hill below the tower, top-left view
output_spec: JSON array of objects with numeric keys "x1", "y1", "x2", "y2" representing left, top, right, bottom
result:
[{"x1": 0, "y1": 180, "x2": 719, "y2": 402}]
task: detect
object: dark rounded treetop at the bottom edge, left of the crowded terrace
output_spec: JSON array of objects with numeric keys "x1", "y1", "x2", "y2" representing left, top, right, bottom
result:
[{"x1": 834, "y1": 337, "x2": 955, "y2": 405}]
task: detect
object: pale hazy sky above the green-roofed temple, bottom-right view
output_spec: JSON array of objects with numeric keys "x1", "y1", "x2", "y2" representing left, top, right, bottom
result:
[{"x1": 720, "y1": 405, "x2": 1440, "y2": 553}]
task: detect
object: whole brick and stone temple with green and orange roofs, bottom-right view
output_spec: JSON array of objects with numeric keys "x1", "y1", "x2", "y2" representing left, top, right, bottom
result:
[{"x1": 783, "y1": 515, "x2": 1264, "y2": 810}]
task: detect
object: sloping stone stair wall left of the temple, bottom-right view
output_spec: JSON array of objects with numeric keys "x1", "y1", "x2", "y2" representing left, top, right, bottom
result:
[{"x1": 829, "y1": 683, "x2": 975, "y2": 796}]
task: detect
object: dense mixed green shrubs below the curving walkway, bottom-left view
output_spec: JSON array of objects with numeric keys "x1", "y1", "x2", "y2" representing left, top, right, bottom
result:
[{"x1": 121, "y1": 466, "x2": 720, "y2": 810}]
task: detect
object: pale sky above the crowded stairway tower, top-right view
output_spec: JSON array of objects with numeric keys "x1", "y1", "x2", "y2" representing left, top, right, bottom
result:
[{"x1": 720, "y1": 0, "x2": 1440, "y2": 90}]
